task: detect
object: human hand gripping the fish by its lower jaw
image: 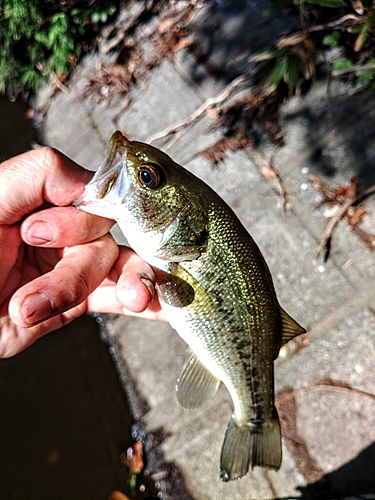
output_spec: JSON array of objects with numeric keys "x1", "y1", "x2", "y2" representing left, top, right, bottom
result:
[{"x1": 0, "y1": 148, "x2": 163, "y2": 357}]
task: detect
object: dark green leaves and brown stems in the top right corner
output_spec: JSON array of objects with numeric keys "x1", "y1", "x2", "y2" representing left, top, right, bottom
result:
[{"x1": 268, "y1": 0, "x2": 375, "y2": 95}]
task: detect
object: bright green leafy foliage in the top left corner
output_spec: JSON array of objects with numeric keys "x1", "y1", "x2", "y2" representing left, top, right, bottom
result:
[{"x1": 0, "y1": 0, "x2": 116, "y2": 95}]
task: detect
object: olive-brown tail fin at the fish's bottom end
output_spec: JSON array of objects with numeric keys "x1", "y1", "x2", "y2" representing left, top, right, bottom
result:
[{"x1": 220, "y1": 410, "x2": 282, "y2": 481}]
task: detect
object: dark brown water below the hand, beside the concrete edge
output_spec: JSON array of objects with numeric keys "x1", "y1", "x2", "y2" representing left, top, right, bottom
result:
[{"x1": 0, "y1": 316, "x2": 136, "y2": 500}]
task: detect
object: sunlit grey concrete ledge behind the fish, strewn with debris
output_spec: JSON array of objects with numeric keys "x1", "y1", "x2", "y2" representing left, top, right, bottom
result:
[{"x1": 32, "y1": 2, "x2": 375, "y2": 500}]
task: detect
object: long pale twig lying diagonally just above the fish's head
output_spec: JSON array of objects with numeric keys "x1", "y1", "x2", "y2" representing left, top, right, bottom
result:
[{"x1": 146, "y1": 67, "x2": 258, "y2": 143}]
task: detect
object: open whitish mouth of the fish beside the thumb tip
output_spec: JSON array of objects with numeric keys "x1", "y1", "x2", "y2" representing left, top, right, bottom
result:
[{"x1": 72, "y1": 147, "x2": 130, "y2": 219}]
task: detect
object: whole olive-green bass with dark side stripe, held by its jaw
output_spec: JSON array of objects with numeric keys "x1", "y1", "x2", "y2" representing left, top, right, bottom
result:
[{"x1": 73, "y1": 131, "x2": 305, "y2": 482}]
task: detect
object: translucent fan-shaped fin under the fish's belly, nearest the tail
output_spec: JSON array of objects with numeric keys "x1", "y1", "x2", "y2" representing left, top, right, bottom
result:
[{"x1": 176, "y1": 352, "x2": 220, "y2": 409}]
